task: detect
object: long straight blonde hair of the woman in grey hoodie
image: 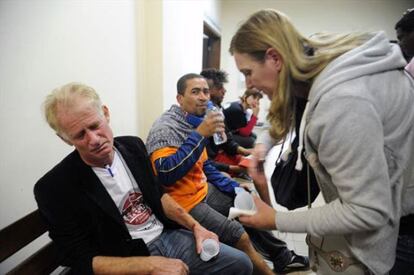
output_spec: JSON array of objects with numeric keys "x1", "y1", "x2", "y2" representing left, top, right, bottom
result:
[{"x1": 229, "y1": 9, "x2": 368, "y2": 141}]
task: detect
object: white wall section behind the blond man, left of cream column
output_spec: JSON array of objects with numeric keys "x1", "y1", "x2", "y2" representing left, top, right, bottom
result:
[{"x1": 0, "y1": 0, "x2": 138, "y2": 274}]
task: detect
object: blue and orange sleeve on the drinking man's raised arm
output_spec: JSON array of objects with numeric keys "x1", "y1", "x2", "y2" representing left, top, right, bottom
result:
[{"x1": 151, "y1": 131, "x2": 207, "y2": 186}]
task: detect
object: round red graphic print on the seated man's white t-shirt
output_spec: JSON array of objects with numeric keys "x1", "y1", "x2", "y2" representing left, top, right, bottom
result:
[{"x1": 122, "y1": 192, "x2": 152, "y2": 225}]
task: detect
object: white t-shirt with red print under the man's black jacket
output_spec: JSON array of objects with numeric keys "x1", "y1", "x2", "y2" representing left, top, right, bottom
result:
[{"x1": 92, "y1": 150, "x2": 164, "y2": 243}]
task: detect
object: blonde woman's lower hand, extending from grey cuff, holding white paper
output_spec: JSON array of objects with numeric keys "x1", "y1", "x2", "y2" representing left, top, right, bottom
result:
[{"x1": 239, "y1": 196, "x2": 276, "y2": 230}]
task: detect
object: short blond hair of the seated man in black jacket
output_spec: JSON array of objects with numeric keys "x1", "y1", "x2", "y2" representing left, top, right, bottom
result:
[{"x1": 43, "y1": 82, "x2": 103, "y2": 134}]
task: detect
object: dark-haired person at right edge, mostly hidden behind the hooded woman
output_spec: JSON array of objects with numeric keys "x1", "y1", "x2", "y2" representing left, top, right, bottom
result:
[{"x1": 390, "y1": 9, "x2": 414, "y2": 275}]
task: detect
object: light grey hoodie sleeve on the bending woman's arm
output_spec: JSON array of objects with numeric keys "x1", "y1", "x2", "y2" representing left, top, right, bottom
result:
[{"x1": 276, "y1": 96, "x2": 393, "y2": 236}]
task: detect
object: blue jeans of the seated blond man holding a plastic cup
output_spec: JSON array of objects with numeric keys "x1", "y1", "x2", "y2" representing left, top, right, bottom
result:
[{"x1": 147, "y1": 229, "x2": 253, "y2": 275}]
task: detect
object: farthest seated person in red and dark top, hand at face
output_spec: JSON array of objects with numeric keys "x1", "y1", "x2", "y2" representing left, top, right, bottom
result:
[{"x1": 223, "y1": 89, "x2": 263, "y2": 148}]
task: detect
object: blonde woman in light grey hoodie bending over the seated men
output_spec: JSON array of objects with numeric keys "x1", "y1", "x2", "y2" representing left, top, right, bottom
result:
[{"x1": 230, "y1": 10, "x2": 414, "y2": 274}]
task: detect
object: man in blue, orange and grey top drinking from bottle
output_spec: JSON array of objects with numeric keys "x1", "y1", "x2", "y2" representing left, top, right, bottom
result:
[{"x1": 146, "y1": 73, "x2": 308, "y2": 274}]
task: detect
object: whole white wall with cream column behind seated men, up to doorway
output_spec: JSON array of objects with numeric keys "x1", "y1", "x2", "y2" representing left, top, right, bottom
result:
[{"x1": 0, "y1": 0, "x2": 220, "y2": 274}]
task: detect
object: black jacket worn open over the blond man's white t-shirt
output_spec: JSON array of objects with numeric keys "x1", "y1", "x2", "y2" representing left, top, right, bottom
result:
[{"x1": 34, "y1": 137, "x2": 177, "y2": 274}]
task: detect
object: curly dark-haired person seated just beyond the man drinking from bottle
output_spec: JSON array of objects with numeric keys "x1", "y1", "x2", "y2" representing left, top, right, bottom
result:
[{"x1": 200, "y1": 68, "x2": 250, "y2": 179}]
